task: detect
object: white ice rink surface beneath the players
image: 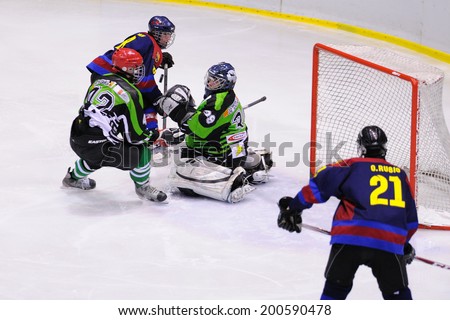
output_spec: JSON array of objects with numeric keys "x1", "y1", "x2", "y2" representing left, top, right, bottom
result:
[{"x1": 0, "y1": 0, "x2": 450, "y2": 300}]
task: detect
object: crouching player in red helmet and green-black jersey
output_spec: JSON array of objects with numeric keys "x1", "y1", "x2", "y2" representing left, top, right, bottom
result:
[{"x1": 63, "y1": 48, "x2": 167, "y2": 202}]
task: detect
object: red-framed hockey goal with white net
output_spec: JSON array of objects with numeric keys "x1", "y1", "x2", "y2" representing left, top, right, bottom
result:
[{"x1": 310, "y1": 44, "x2": 450, "y2": 230}]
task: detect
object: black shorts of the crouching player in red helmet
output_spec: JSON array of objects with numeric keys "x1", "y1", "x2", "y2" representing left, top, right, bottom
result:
[{"x1": 70, "y1": 118, "x2": 145, "y2": 170}]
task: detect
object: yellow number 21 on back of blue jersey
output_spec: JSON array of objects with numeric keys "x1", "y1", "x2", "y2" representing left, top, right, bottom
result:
[{"x1": 370, "y1": 175, "x2": 405, "y2": 208}]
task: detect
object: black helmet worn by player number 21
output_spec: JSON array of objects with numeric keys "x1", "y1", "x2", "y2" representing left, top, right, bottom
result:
[{"x1": 356, "y1": 126, "x2": 387, "y2": 158}]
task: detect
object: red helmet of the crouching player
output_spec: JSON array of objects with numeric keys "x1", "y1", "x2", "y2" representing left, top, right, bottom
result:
[{"x1": 112, "y1": 48, "x2": 144, "y2": 84}]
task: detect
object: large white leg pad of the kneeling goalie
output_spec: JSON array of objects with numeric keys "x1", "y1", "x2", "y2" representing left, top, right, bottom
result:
[{"x1": 169, "y1": 157, "x2": 254, "y2": 203}]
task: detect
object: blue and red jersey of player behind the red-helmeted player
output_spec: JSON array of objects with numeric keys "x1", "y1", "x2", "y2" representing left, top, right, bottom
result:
[{"x1": 86, "y1": 32, "x2": 162, "y2": 130}]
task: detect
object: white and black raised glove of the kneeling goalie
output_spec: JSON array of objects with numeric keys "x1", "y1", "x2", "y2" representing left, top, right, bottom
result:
[{"x1": 157, "y1": 84, "x2": 195, "y2": 125}]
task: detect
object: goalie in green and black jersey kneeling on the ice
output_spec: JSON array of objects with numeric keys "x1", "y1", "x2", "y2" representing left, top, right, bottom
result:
[{"x1": 159, "y1": 62, "x2": 272, "y2": 202}]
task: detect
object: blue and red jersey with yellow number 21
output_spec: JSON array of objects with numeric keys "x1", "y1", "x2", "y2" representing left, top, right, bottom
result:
[{"x1": 290, "y1": 158, "x2": 418, "y2": 254}]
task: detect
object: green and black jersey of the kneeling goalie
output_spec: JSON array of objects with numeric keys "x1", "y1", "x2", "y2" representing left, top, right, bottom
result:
[{"x1": 183, "y1": 90, "x2": 248, "y2": 165}]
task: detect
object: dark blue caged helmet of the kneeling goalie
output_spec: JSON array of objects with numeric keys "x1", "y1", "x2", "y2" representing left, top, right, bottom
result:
[{"x1": 205, "y1": 62, "x2": 237, "y2": 93}]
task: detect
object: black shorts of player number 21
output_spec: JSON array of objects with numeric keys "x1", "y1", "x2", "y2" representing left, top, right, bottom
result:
[{"x1": 325, "y1": 244, "x2": 408, "y2": 294}]
